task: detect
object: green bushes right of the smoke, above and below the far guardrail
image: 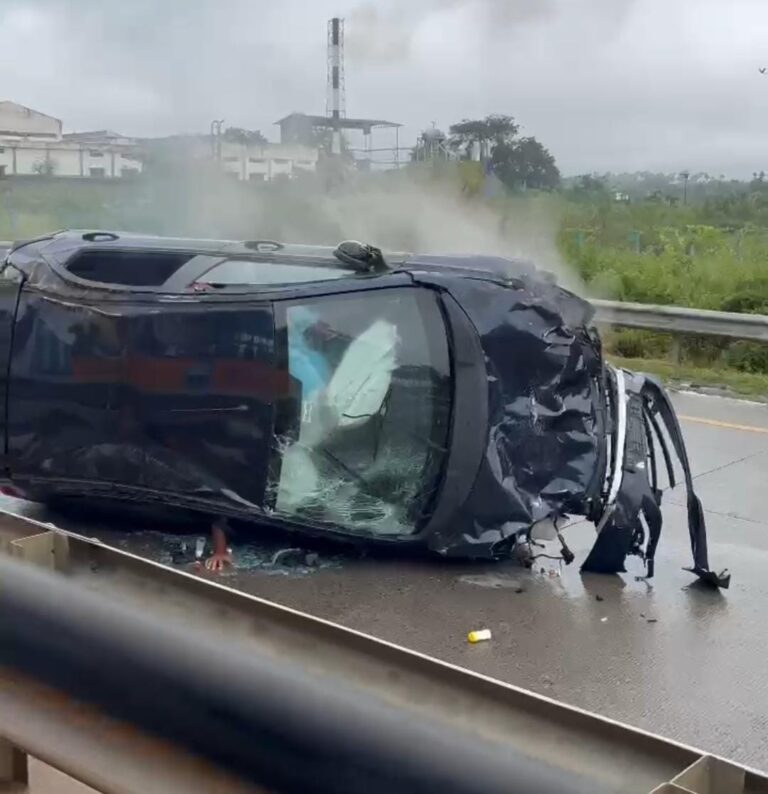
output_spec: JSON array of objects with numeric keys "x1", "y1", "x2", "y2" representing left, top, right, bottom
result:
[{"x1": 558, "y1": 174, "x2": 768, "y2": 386}]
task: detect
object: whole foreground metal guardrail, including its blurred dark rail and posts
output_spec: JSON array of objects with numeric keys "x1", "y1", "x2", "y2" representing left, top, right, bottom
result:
[{"x1": 0, "y1": 512, "x2": 768, "y2": 794}]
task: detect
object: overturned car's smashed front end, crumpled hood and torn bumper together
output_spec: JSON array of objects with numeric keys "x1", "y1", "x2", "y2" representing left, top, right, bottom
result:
[{"x1": 420, "y1": 275, "x2": 730, "y2": 587}]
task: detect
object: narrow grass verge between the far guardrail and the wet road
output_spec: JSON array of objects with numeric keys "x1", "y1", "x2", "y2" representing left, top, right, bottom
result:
[{"x1": 606, "y1": 354, "x2": 768, "y2": 400}]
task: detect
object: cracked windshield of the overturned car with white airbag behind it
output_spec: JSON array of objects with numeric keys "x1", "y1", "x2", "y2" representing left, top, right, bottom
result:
[{"x1": 272, "y1": 288, "x2": 453, "y2": 536}]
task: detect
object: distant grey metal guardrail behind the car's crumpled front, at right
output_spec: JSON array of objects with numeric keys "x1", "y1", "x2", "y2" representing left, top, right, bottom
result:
[{"x1": 591, "y1": 300, "x2": 768, "y2": 342}]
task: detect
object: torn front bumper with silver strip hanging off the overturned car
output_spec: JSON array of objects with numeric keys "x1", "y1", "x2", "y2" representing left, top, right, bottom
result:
[{"x1": 582, "y1": 370, "x2": 730, "y2": 588}]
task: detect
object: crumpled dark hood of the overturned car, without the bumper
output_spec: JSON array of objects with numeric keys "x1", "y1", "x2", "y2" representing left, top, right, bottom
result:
[{"x1": 424, "y1": 279, "x2": 606, "y2": 557}]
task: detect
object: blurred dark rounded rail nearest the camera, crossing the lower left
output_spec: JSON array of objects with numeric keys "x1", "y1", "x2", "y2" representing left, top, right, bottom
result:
[{"x1": 0, "y1": 559, "x2": 600, "y2": 794}]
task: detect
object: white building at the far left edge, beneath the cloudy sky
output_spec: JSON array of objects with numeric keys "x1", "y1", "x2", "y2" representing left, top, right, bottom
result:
[{"x1": 0, "y1": 101, "x2": 142, "y2": 178}]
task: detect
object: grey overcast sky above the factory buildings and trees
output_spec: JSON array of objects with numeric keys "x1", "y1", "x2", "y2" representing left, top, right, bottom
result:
[{"x1": 0, "y1": 0, "x2": 768, "y2": 176}]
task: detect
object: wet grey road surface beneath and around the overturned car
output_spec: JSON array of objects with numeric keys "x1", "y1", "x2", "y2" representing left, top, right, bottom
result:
[{"x1": 1, "y1": 394, "x2": 768, "y2": 769}]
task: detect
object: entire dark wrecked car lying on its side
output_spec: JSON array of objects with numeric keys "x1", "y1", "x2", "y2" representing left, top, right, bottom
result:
[{"x1": 0, "y1": 231, "x2": 729, "y2": 586}]
